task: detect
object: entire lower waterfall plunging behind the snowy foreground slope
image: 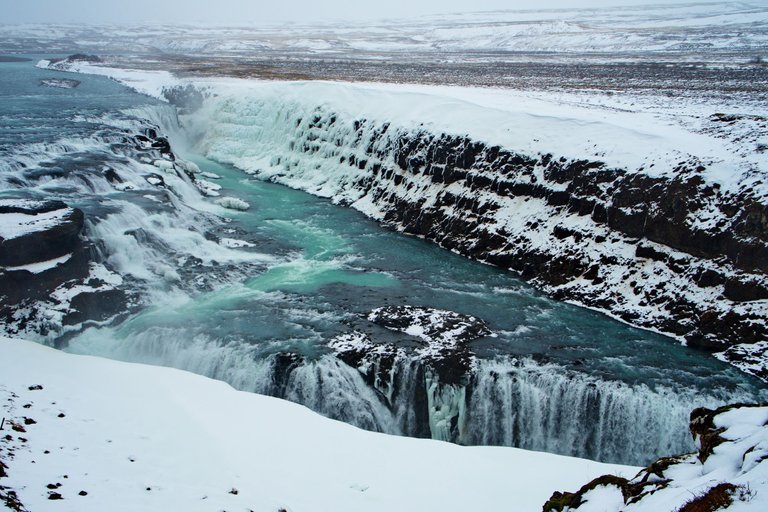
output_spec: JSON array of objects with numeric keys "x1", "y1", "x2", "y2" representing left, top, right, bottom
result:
[{"x1": 70, "y1": 317, "x2": 754, "y2": 465}]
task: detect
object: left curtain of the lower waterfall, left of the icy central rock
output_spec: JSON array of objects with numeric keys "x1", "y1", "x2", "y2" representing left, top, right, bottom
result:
[{"x1": 69, "y1": 328, "x2": 403, "y2": 435}]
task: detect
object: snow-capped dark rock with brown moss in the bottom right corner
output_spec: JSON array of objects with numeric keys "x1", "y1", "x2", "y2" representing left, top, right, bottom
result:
[{"x1": 543, "y1": 405, "x2": 768, "y2": 512}]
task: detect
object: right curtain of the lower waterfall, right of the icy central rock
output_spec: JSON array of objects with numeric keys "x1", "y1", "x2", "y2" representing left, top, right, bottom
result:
[{"x1": 462, "y1": 360, "x2": 754, "y2": 464}]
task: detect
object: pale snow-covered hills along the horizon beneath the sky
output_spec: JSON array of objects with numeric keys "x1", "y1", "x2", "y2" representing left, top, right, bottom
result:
[{"x1": 0, "y1": 2, "x2": 768, "y2": 62}]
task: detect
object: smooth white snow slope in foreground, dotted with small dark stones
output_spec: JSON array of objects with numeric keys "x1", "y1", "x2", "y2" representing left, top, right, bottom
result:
[{"x1": 0, "y1": 338, "x2": 637, "y2": 512}]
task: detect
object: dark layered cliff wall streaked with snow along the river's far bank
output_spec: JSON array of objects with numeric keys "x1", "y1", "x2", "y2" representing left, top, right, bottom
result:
[{"x1": 234, "y1": 108, "x2": 768, "y2": 379}]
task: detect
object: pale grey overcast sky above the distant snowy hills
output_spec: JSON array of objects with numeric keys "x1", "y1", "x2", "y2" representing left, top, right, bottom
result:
[{"x1": 0, "y1": 0, "x2": 712, "y2": 24}]
